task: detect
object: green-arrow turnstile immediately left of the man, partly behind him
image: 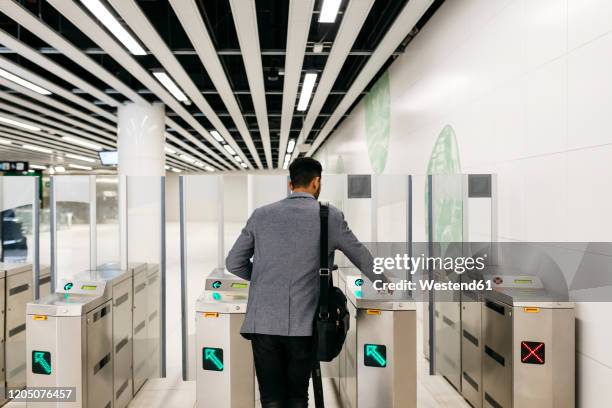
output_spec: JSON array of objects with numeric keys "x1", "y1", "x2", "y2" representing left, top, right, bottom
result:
[{"x1": 196, "y1": 269, "x2": 255, "y2": 408}]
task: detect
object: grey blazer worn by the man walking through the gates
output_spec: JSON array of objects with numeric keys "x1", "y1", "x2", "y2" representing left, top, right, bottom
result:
[{"x1": 226, "y1": 193, "x2": 372, "y2": 336}]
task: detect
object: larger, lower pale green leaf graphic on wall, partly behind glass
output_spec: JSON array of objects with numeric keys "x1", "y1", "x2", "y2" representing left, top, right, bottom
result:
[{"x1": 425, "y1": 125, "x2": 463, "y2": 242}]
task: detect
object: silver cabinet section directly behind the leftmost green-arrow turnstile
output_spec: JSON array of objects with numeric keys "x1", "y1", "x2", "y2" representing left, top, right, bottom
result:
[{"x1": 74, "y1": 265, "x2": 133, "y2": 408}]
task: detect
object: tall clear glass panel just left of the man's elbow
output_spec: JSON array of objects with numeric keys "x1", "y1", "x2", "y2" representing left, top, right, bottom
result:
[{"x1": 180, "y1": 175, "x2": 221, "y2": 379}]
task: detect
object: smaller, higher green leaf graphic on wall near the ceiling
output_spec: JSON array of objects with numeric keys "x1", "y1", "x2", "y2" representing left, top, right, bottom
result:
[{"x1": 365, "y1": 72, "x2": 391, "y2": 174}]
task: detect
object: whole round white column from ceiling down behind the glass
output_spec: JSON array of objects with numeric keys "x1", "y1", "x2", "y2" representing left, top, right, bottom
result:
[{"x1": 117, "y1": 103, "x2": 166, "y2": 268}]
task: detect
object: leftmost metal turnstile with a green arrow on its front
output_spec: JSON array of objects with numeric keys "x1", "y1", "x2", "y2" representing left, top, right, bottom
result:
[{"x1": 26, "y1": 279, "x2": 113, "y2": 408}]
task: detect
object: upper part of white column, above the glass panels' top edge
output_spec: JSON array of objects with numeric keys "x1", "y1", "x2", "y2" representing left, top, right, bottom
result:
[{"x1": 117, "y1": 103, "x2": 166, "y2": 176}]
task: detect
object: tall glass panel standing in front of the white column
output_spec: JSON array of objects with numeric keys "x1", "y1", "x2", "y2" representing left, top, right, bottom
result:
[{"x1": 126, "y1": 176, "x2": 163, "y2": 381}]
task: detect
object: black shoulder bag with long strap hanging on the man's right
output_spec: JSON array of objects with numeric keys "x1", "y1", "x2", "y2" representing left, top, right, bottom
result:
[{"x1": 315, "y1": 203, "x2": 350, "y2": 361}]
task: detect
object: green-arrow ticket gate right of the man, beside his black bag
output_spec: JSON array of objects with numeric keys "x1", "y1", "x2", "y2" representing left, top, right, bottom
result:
[{"x1": 335, "y1": 268, "x2": 417, "y2": 408}]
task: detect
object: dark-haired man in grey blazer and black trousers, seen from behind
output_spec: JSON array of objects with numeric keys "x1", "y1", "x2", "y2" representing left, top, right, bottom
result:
[{"x1": 226, "y1": 158, "x2": 380, "y2": 408}]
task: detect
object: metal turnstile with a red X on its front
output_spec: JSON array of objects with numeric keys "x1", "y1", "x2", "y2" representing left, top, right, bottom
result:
[{"x1": 482, "y1": 275, "x2": 575, "y2": 408}]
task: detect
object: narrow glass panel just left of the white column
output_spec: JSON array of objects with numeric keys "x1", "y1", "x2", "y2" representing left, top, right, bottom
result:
[{"x1": 96, "y1": 176, "x2": 121, "y2": 265}]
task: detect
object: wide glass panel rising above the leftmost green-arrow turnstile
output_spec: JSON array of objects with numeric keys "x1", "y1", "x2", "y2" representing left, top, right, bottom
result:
[{"x1": 51, "y1": 176, "x2": 91, "y2": 283}]
